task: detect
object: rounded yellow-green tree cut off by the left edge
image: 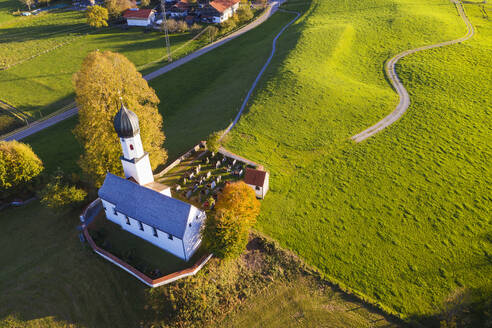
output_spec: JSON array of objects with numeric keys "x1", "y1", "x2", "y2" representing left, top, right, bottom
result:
[{"x1": 0, "y1": 140, "x2": 43, "y2": 196}]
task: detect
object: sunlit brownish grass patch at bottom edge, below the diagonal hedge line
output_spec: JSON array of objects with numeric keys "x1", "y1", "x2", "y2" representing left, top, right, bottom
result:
[{"x1": 222, "y1": 277, "x2": 398, "y2": 328}]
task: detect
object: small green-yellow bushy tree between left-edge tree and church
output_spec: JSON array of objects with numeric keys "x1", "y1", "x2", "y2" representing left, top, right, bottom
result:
[{"x1": 39, "y1": 170, "x2": 87, "y2": 209}]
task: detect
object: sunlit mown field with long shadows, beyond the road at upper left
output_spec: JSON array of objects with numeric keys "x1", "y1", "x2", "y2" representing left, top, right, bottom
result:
[{"x1": 0, "y1": 7, "x2": 205, "y2": 128}]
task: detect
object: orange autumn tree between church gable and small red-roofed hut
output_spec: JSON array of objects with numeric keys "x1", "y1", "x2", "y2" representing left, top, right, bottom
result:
[{"x1": 203, "y1": 181, "x2": 260, "y2": 258}]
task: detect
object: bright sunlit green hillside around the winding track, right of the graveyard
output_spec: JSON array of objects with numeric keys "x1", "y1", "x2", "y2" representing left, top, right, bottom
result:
[{"x1": 228, "y1": 0, "x2": 492, "y2": 320}]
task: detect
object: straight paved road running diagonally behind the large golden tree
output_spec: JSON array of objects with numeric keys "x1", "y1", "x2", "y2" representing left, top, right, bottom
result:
[{"x1": 4, "y1": 1, "x2": 283, "y2": 140}]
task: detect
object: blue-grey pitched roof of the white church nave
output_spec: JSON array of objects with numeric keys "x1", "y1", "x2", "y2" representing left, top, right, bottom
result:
[{"x1": 98, "y1": 173, "x2": 192, "y2": 239}]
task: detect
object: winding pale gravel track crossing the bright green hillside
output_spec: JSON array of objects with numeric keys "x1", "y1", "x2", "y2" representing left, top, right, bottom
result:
[{"x1": 351, "y1": 0, "x2": 475, "y2": 142}]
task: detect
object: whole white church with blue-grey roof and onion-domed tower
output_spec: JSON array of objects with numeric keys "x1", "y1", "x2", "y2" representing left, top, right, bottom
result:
[{"x1": 98, "y1": 104, "x2": 206, "y2": 261}]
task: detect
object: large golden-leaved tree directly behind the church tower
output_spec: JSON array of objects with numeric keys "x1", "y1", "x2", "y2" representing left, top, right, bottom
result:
[{"x1": 73, "y1": 51, "x2": 167, "y2": 187}]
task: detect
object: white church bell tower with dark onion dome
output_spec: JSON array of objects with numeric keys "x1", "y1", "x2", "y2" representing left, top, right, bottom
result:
[{"x1": 113, "y1": 102, "x2": 154, "y2": 185}]
